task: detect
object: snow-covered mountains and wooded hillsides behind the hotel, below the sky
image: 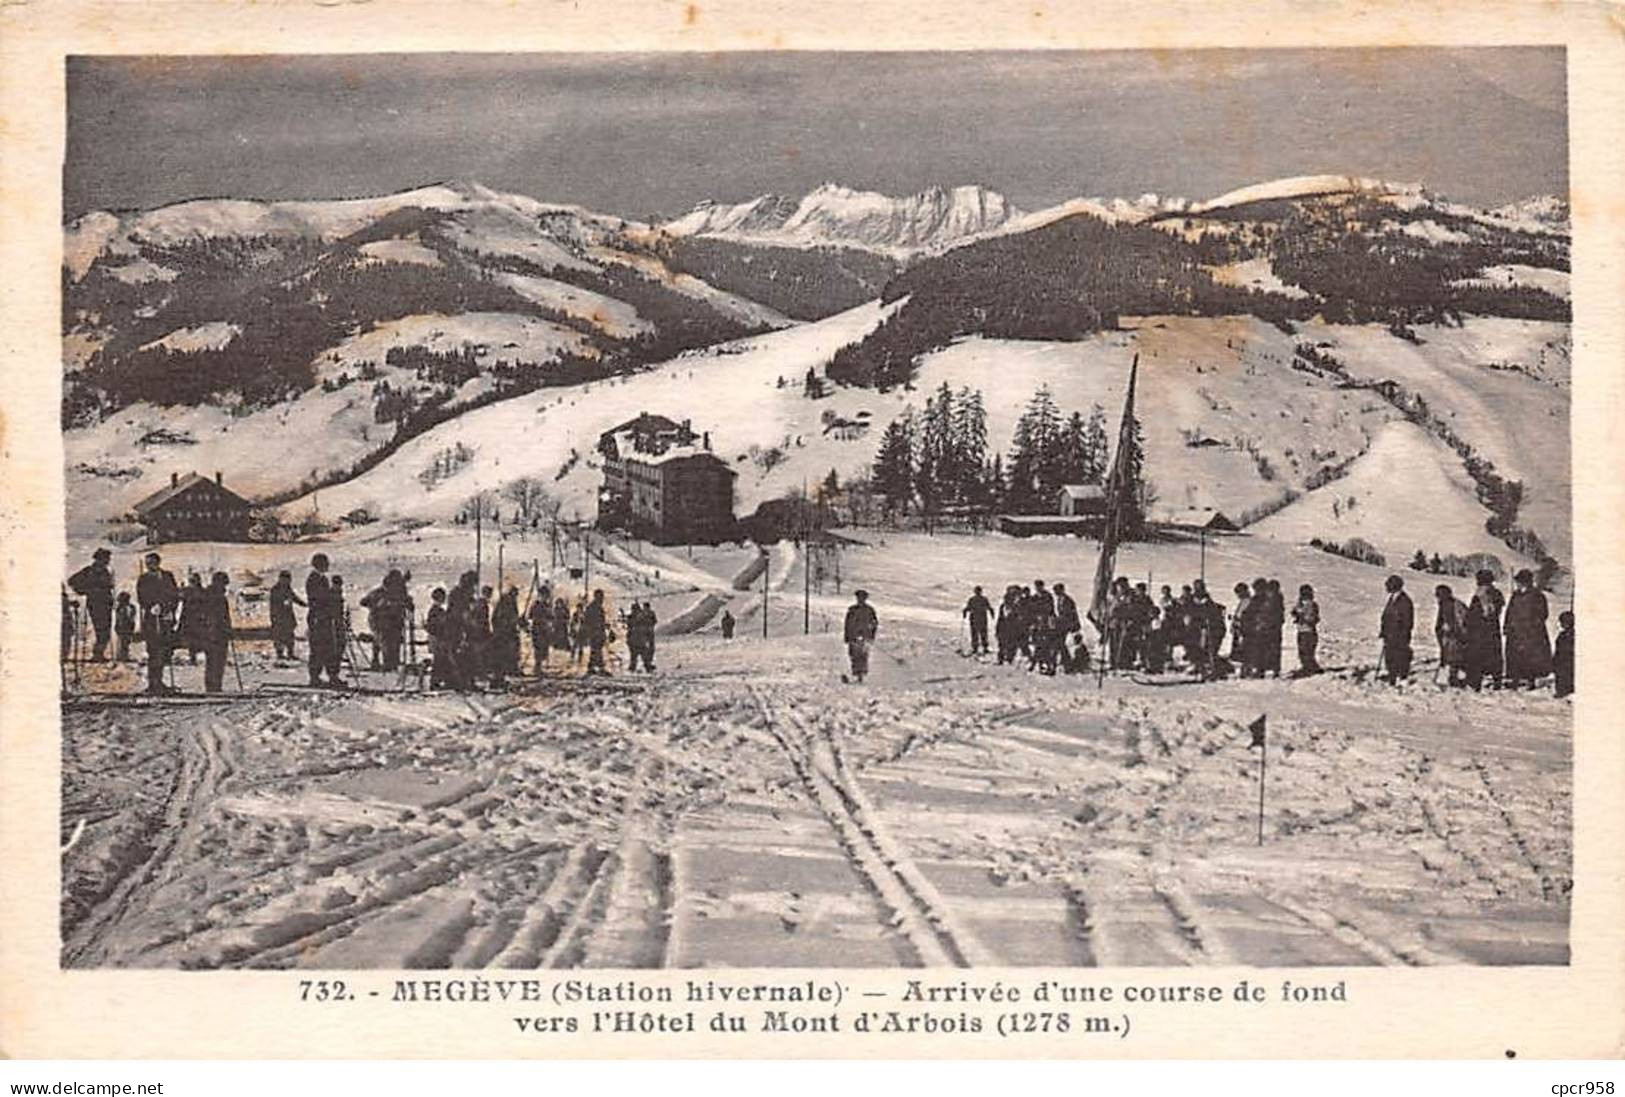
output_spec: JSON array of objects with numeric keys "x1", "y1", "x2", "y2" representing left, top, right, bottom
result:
[{"x1": 63, "y1": 177, "x2": 1570, "y2": 575}]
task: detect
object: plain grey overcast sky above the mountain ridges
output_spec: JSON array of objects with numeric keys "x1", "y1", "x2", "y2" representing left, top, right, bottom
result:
[{"x1": 63, "y1": 49, "x2": 1568, "y2": 218}]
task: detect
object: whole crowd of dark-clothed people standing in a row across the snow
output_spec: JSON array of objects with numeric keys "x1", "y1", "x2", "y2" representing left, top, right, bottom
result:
[{"x1": 62, "y1": 549, "x2": 1575, "y2": 697}]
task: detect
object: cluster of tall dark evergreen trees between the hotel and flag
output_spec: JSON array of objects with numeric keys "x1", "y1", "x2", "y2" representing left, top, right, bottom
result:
[{"x1": 873, "y1": 382, "x2": 1139, "y2": 517}]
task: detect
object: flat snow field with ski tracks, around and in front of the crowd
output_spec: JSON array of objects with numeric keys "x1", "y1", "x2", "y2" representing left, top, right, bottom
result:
[{"x1": 62, "y1": 528, "x2": 1571, "y2": 969}]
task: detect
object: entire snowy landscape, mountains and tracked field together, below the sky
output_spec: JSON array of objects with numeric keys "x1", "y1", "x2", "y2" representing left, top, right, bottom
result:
[{"x1": 62, "y1": 167, "x2": 1573, "y2": 969}]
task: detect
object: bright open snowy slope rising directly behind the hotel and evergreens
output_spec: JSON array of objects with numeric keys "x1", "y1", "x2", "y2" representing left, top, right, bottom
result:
[{"x1": 269, "y1": 304, "x2": 1462, "y2": 539}]
